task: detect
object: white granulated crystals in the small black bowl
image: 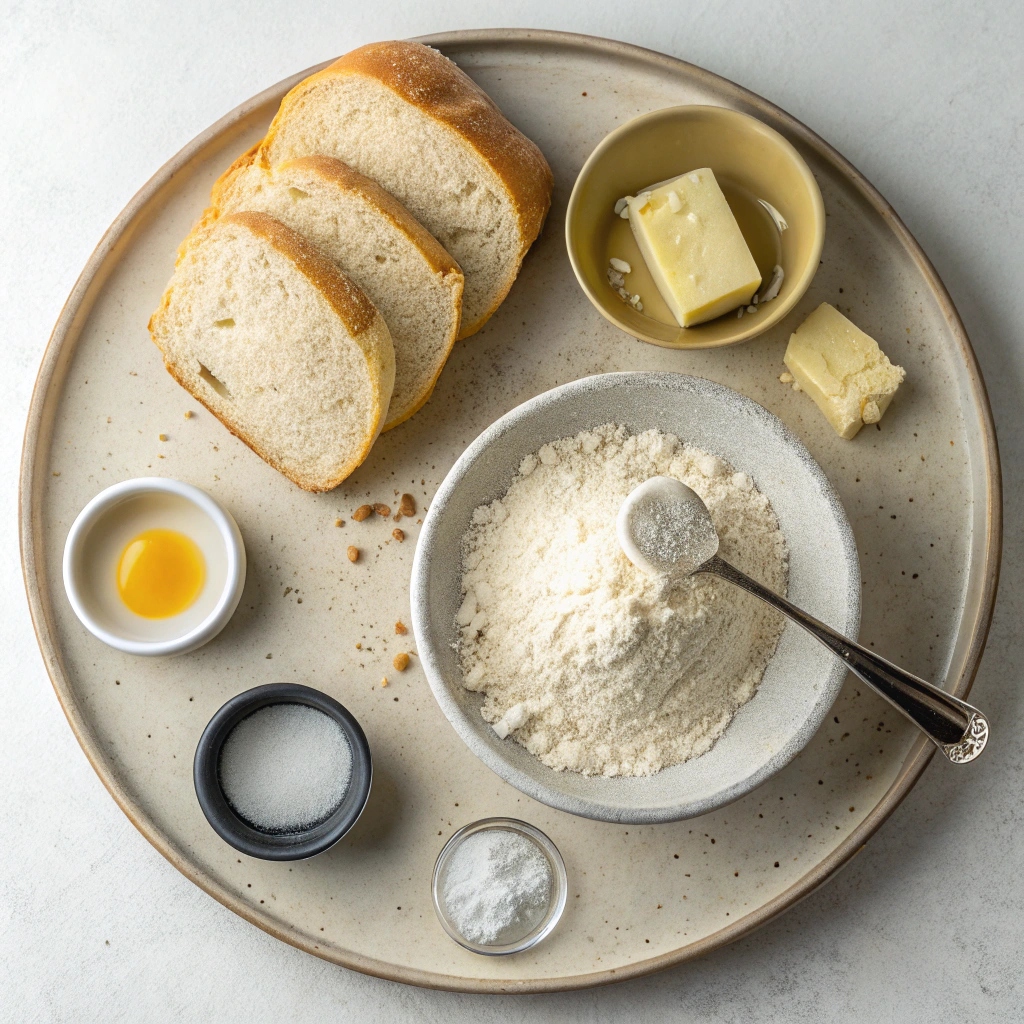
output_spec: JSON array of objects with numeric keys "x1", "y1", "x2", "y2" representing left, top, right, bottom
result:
[{"x1": 220, "y1": 703, "x2": 352, "y2": 833}]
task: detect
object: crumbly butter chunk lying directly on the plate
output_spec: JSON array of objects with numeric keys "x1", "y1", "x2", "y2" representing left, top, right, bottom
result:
[{"x1": 782, "y1": 302, "x2": 906, "y2": 438}]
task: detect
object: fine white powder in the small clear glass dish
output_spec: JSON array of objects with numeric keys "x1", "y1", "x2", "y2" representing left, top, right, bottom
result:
[{"x1": 442, "y1": 828, "x2": 551, "y2": 946}]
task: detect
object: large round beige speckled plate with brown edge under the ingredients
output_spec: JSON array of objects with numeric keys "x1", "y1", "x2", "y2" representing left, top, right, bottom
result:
[{"x1": 20, "y1": 31, "x2": 1000, "y2": 991}]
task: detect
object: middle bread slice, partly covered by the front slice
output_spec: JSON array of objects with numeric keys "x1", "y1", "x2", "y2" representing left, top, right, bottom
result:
[{"x1": 207, "y1": 151, "x2": 463, "y2": 430}]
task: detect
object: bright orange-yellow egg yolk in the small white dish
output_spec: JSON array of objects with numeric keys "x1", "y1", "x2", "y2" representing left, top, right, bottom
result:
[{"x1": 118, "y1": 529, "x2": 206, "y2": 618}]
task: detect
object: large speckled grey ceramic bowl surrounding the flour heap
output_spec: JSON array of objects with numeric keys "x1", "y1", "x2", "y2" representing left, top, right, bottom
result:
[{"x1": 412, "y1": 373, "x2": 860, "y2": 824}]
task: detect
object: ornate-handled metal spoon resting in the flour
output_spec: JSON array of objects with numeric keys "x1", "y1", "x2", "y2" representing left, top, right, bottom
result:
[{"x1": 616, "y1": 476, "x2": 988, "y2": 764}]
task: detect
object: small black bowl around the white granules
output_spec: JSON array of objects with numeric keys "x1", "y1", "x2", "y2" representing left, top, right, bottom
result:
[{"x1": 193, "y1": 683, "x2": 373, "y2": 860}]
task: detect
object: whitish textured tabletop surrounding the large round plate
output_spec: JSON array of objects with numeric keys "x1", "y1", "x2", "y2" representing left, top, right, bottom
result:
[{"x1": 0, "y1": 0, "x2": 1024, "y2": 1024}]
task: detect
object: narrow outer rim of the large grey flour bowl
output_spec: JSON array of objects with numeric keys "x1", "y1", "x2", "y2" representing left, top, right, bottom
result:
[{"x1": 410, "y1": 371, "x2": 861, "y2": 824}]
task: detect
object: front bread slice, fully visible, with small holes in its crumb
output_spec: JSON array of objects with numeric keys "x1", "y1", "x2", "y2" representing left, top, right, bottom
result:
[{"x1": 150, "y1": 212, "x2": 394, "y2": 490}]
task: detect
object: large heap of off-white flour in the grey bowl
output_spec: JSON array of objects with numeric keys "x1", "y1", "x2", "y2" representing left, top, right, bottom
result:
[{"x1": 457, "y1": 424, "x2": 787, "y2": 776}]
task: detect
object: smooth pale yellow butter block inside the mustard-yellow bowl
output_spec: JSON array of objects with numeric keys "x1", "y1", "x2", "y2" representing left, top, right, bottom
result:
[{"x1": 627, "y1": 167, "x2": 761, "y2": 327}]
